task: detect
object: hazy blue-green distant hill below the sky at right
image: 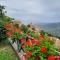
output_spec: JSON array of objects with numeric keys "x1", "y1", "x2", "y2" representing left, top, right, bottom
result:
[{"x1": 36, "y1": 22, "x2": 60, "y2": 37}]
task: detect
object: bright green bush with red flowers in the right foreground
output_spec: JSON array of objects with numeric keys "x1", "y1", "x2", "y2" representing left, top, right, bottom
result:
[{"x1": 22, "y1": 30, "x2": 58, "y2": 60}]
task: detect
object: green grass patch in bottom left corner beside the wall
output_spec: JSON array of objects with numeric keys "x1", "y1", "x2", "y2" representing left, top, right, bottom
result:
[{"x1": 0, "y1": 43, "x2": 18, "y2": 60}]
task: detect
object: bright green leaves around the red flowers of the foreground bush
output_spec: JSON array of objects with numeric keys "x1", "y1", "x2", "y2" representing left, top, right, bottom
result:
[{"x1": 24, "y1": 32, "x2": 58, "y2": 60}]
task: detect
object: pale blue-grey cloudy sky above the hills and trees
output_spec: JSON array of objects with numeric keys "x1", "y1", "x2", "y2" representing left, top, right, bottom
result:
[{"x1": 0, "y1": 0, "x2": 60, "y2": 23}]
